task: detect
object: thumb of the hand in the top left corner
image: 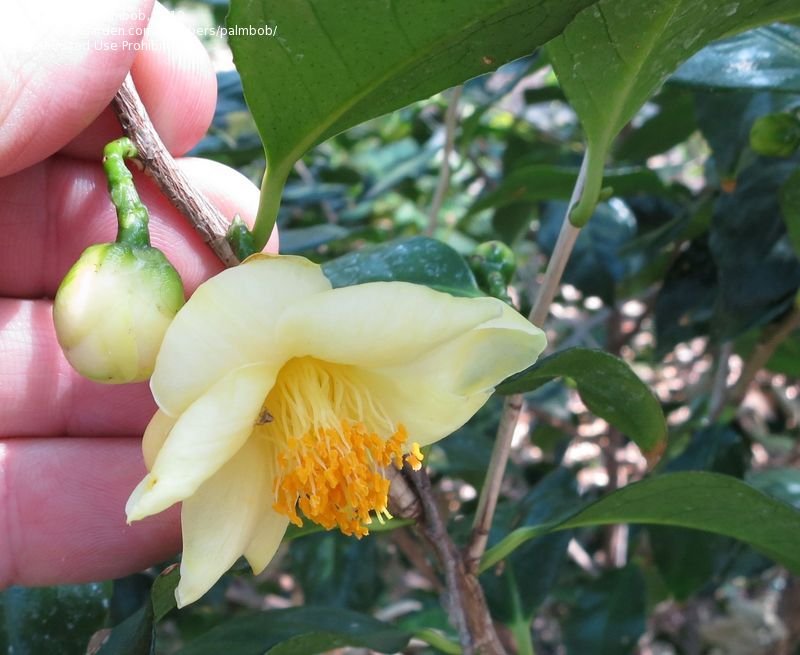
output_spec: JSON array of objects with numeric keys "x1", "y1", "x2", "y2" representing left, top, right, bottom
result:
[{"x1": 0, "y1": 0, "x2": 154, "y2": 176}]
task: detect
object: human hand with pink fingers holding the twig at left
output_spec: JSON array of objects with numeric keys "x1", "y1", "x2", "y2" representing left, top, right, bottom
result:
[{"x1": 0, "y1": 0, "x2": 277, "y2": 589}]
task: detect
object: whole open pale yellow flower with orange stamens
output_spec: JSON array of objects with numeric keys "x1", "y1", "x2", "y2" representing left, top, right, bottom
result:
[{"x1": 126, "y1": 256, "x2": 545, "y2": 606}]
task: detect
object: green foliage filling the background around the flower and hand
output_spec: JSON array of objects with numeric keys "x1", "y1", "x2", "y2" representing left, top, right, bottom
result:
[{"x1": 0, "y1": 0, "x2": 800, "y2": 655}]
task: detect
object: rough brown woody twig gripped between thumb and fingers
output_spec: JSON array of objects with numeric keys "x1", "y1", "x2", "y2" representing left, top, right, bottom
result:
[{"x1": 111, "y1": 74, "x2": 239, "y2": 266}]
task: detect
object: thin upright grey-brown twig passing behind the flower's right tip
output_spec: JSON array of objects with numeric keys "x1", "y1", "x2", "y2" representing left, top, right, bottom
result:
[{"x1": 465, "y1": 150, "x2": 589, "y2": 571}]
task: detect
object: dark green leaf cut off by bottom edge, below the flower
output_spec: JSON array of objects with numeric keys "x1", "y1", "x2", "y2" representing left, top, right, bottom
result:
[{"x1": 178, "y1": 607, "x2": 411, "y2": 655}]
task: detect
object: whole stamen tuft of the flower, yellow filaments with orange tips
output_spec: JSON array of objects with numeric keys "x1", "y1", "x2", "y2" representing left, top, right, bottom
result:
[{"x1": 256, "y1": 357, "x2": 422, "y2": 537}]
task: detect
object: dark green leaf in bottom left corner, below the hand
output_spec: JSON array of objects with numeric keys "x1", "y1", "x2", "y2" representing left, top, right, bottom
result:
[{"x1": 0, "y1": 583, "x2": 111, "y2": 655}]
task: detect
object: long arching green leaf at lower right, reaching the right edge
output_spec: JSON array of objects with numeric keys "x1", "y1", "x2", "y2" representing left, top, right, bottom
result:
[{"x1": 481, "y1": 471, "x2": 800, "y2": 573}]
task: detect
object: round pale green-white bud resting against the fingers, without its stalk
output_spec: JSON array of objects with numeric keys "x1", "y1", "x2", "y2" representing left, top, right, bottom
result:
[{"x1": 53, "y1": 243, "x2": 184, "y2": 383}]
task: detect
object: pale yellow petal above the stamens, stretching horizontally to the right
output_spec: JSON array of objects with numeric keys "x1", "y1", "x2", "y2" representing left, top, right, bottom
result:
[{"x1": 278, "y1": 282, "x2": 502, "y2": 368}]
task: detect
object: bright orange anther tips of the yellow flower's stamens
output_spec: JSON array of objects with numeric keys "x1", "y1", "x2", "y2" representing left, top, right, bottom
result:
[{"x1": 273, "y1": 420, "x2": 422, "y2": 538}]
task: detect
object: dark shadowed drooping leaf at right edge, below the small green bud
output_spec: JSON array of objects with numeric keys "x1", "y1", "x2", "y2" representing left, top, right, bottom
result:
[{"x1": 709, "y1": 158, "x2": 800, "y2": 338}]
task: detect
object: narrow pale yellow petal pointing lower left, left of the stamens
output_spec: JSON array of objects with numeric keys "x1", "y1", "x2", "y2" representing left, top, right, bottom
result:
[{"x1": 125, "y1": 365, "x2": 276, "y2": 521}]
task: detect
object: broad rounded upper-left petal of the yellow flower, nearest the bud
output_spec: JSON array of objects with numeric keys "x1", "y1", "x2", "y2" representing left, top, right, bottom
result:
[{"x1": 150, "y1": 255, "x2": 330, "y2": 416}]
